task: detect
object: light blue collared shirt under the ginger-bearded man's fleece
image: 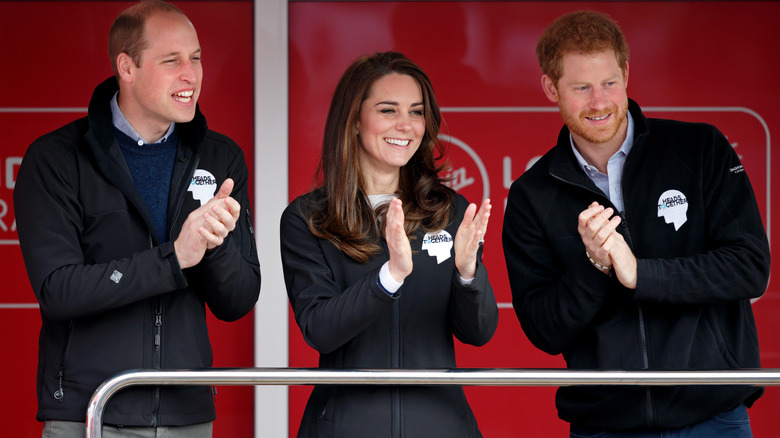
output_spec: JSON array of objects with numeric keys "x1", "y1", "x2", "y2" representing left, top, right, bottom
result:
[{"x1": 569, "y1": 112, "x2": 634, "y2": 212}]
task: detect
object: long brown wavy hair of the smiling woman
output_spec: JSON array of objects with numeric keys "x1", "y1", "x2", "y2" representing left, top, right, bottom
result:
[{"x1": 309, "y1": 52, "x2": 455, "y2": 263}]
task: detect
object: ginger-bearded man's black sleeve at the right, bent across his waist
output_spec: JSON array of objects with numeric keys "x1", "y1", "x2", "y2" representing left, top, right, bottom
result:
[{"x1": 635, "y1": 125, "x2": 770, "y2": 304}]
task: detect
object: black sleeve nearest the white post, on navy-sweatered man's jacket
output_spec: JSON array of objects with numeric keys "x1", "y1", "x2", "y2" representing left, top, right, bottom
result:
[{"x1": 188, "y1": 144, "x2": 260, "y2": 321}]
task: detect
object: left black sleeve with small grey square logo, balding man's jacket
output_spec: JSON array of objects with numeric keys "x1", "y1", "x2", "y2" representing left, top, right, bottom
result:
[{"x1": 14, "y1": 134, "x2": 186, "y2": 320}]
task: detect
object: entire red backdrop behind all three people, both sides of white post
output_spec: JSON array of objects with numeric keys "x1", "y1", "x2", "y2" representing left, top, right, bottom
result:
[{"x1": 0, "y1": 1, "x2": 780, "y2": 437}]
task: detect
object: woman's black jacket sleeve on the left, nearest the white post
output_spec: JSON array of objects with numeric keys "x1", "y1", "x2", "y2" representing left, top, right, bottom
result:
[{"x1": 280, "y1": 198, "x2": 400, "y2": 354}]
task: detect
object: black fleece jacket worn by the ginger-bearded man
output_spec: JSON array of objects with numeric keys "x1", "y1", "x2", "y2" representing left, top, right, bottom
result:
[{"x1": 503, "y1": 101, "x2": 770, "y2": 430}]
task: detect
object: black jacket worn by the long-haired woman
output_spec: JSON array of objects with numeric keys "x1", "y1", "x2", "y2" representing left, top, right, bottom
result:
[{"x1": 281, "y1": 191, "x2": 498, "y2": 438}]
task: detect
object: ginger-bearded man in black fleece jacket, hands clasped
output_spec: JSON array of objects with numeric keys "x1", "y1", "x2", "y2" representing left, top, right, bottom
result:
[{"x1": 503, "y1": 11, "x2": 770, "y2": 438}]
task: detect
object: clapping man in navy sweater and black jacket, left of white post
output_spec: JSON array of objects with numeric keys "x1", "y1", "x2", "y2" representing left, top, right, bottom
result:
[{"x1": 14, "y1": 0, "x2": 260, "y2": 438}]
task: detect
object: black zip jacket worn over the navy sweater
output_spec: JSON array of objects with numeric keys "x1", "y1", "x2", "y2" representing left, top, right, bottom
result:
[{"x1": 14, "y1": 78, "x2": 260, "y2": 426}]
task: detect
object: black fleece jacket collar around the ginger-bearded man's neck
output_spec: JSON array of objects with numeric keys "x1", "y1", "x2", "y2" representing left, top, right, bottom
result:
[{"x1": 550, "y1": 99, "x2": 650, "y2": 187}]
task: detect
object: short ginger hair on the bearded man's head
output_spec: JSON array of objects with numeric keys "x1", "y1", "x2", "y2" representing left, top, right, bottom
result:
[{"x1": 536, "y1": 11, "x2": 628, "y2": 85}]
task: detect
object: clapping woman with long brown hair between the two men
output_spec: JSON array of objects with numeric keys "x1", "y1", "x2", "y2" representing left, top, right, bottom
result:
[{"x1": 281, "y1": 52, "x2": 498, "y2": 438}]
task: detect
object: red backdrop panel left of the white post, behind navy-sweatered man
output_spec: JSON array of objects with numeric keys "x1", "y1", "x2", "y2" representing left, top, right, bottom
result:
[{"x1": 0, "y1": 1, "x2": 254, "y2": 437}]
